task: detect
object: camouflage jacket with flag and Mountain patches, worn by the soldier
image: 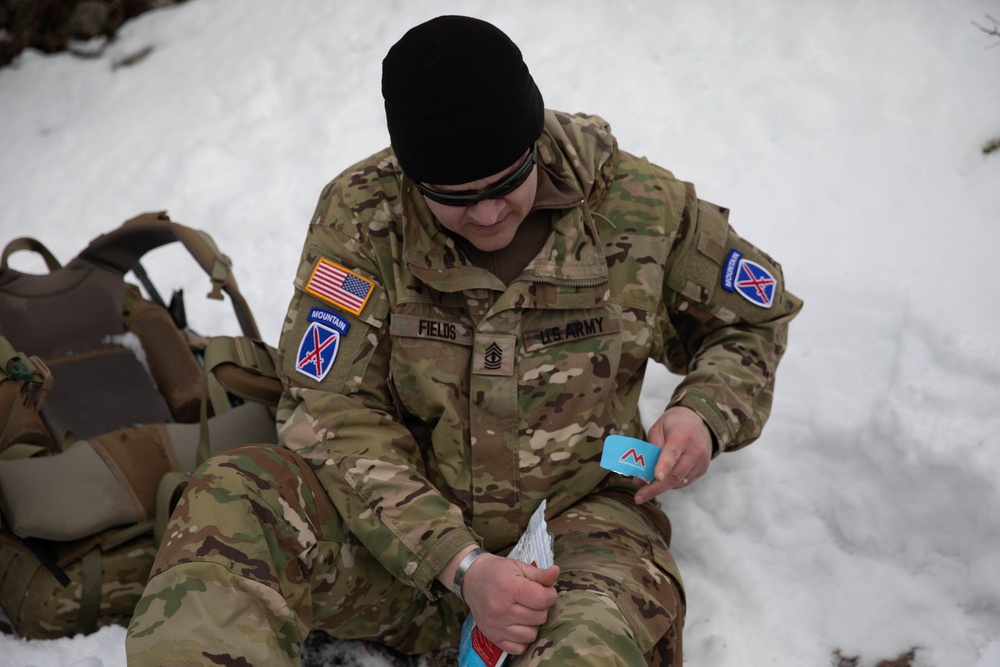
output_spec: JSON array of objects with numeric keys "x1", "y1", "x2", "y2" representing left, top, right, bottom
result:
[{"x1": 278, "y1": 111, "x2": 801, "y2": 596}]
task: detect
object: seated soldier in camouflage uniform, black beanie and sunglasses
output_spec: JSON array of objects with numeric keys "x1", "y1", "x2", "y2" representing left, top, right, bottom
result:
[{"x1": 127, "y1": 11, "x2": 801, "y2": 666}]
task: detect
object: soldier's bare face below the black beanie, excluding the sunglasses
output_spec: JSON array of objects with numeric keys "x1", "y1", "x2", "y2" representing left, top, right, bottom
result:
[{"x1": 423, "y1": 149, "x2": 538, "y2": 251}]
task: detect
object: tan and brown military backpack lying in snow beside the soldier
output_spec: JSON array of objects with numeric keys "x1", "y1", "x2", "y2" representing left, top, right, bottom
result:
[{"x1": 0, "y1": 212, "x2": 281, "y2": 639}]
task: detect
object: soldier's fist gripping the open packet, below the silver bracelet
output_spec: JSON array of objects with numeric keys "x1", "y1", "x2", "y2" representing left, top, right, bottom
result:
[{"x1": 462, "y1": 554, "x2": 559, "y2": 655}]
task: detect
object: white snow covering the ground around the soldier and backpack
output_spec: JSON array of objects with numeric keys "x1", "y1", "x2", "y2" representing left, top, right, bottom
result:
[{"x1": 0, "y1": 0, "x2": 1000, "y2": 667}]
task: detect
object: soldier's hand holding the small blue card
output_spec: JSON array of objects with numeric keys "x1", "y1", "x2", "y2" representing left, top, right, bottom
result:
[{"x1": 635, "y1": 406, "x2": 712, "y2": 505}]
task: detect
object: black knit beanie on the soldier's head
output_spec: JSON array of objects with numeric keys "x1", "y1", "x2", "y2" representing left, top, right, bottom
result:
[{"x1": 382, "y1": 16, "x2": 544, "y2": 185}]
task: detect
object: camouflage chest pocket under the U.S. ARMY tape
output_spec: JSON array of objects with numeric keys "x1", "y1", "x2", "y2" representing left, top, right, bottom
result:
[{"x1": 517, "y1": 304, "x2": 622, "y2": 440}]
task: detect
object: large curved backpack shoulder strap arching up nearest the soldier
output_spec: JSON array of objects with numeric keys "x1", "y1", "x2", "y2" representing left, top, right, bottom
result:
[{"x1": 79, "y1": 211, "x2": 260, "y2": 338}]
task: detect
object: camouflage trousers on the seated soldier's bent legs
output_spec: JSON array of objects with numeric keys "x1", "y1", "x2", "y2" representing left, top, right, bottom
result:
[{"x1": 126, "y1": 445, "x2": 684, "y2": 667}]
